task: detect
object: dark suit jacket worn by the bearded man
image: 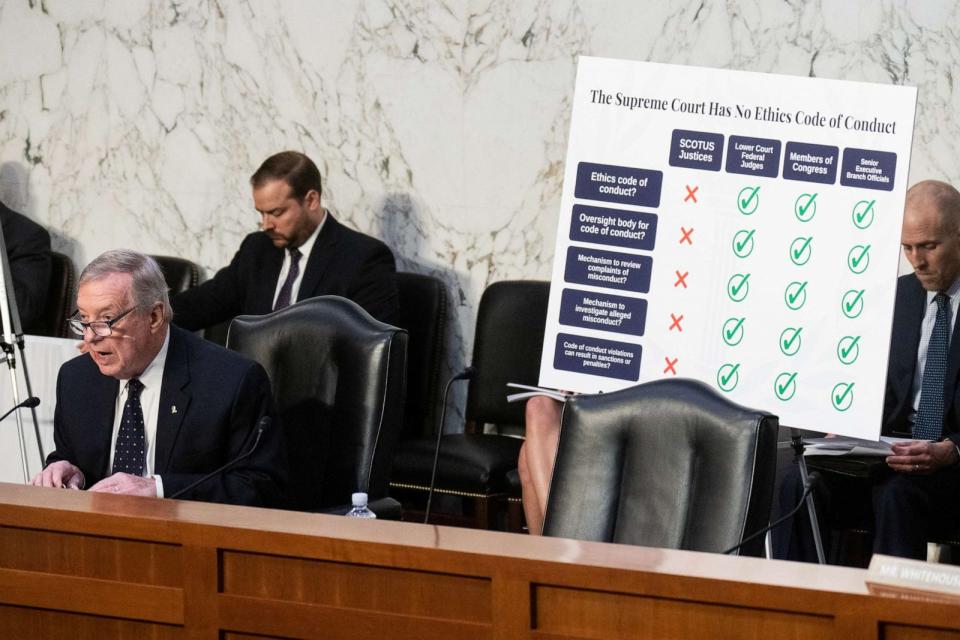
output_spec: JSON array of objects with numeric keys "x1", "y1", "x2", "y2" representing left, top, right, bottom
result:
[{"x1": 170, "y1": 213, "x2": 398, "y2": 331}]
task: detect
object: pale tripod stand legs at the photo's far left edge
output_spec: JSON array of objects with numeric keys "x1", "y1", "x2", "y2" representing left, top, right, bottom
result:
[{"x1": 0, "y1": 220, "x2": 44, "y2": 484}]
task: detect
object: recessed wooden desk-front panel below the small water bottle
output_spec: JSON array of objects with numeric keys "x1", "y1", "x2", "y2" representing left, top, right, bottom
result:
[{"x1": 221, "y1": 551, "x2": 490, "y2": 624}]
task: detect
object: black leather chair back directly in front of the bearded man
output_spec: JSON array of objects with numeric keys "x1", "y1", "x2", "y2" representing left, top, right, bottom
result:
[{"x1": 227, "y1": 296, "x2": 407, "y2": 510}]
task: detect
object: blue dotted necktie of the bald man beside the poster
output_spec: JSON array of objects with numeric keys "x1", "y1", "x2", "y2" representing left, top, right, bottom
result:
[{"x1": 913, "y1": 293, "x2": 950, "y2": 440}]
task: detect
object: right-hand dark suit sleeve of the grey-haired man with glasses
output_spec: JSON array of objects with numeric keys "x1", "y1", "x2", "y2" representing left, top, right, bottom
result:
[{"x1": 161, "y1": 362, "x2": 287, "y2": 507}]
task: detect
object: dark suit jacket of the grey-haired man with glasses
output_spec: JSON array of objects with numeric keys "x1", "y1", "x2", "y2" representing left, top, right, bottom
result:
[{"x1": 47, "y1": 327, "x2": 286, "y2": 506}]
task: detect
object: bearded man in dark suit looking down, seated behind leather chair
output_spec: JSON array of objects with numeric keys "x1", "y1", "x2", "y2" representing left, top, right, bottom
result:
[{"x1": 171, "y1": 151, "x2": 398, "y2": 330}]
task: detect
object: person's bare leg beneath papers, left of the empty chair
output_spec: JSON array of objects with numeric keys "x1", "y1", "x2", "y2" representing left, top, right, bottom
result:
[{"x1": 517, "y1": 396, "x2": 563, "y2": 535}]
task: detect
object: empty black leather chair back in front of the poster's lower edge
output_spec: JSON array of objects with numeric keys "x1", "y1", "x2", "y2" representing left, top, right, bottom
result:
[{"x1": 544, "y1": 379, "x2": 778, "y2": 555}]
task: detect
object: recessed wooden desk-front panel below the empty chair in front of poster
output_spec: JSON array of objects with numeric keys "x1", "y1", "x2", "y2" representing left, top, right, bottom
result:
[{"x1": 533, "y1": 585, "x2": 832, "y2": 640}]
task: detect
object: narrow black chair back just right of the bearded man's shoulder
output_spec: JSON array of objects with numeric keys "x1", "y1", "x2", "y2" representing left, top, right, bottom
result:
[{"x1": 397, "y1": 272, "x2": 447, "y2": 440}]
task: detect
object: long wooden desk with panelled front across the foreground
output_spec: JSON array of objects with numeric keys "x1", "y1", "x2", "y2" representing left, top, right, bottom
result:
[{"x1": 0, "y1": 484, "x2": 960, "y2": 640}]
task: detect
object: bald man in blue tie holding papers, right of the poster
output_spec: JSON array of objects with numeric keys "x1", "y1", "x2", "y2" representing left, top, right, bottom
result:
[{"x1": 777, "y1": 180, "x2": 960, "y2": 560}]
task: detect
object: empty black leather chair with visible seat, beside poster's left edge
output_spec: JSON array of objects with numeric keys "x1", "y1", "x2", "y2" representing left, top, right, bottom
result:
[{"x1": 391, "y1": 280, "x2": 550, "y2": 529}]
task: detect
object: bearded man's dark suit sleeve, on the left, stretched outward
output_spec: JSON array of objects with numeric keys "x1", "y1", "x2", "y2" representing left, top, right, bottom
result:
[{"x1": 170, "y1": 237, "x2": 250, "y2": 331}]
